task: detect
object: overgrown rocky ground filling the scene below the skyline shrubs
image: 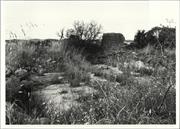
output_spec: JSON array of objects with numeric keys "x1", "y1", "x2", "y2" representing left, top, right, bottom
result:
[{"x1": 6, "y1": 40, "x2": 175, "y2": 124}]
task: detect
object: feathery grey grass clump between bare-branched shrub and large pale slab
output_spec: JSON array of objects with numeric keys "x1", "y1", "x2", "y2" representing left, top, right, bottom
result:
[{"x1": 60, "y1": 43, "x2": 91, "y2": 83}]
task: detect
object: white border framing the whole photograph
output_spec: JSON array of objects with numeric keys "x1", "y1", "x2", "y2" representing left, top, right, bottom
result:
[{"x1": 0, "y1": 0, "x2": 180, "y2": 129}]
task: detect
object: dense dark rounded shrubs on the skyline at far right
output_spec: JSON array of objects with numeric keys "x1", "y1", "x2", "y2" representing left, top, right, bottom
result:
[{"x1": 134, "y1": 26, "x2": 176, "y2": 50}]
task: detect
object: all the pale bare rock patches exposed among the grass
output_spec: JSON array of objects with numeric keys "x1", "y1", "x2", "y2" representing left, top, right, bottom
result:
[{"x1": 5, "y1": 61, "x2": 156, "y2": 122}]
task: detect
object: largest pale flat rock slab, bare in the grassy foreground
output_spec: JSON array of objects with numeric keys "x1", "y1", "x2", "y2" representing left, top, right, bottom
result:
[{"x1": 33, "y1": 83, "x2": 97, "y2": 112}]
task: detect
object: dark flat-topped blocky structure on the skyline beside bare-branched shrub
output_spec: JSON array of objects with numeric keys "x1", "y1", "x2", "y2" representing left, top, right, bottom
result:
[{"x1": 102, "y1": 33, "x2": 125, "y2": 53}]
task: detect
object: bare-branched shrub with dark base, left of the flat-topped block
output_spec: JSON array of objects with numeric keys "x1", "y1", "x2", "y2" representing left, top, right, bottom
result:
[{"x1": 57, "y1": 21, "x2": 102, "y2": 62}]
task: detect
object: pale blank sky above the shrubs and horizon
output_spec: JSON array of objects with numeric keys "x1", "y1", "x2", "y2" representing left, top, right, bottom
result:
[{"x1": 2, "y1": 1, "x2": 179, "y2": 40}]
